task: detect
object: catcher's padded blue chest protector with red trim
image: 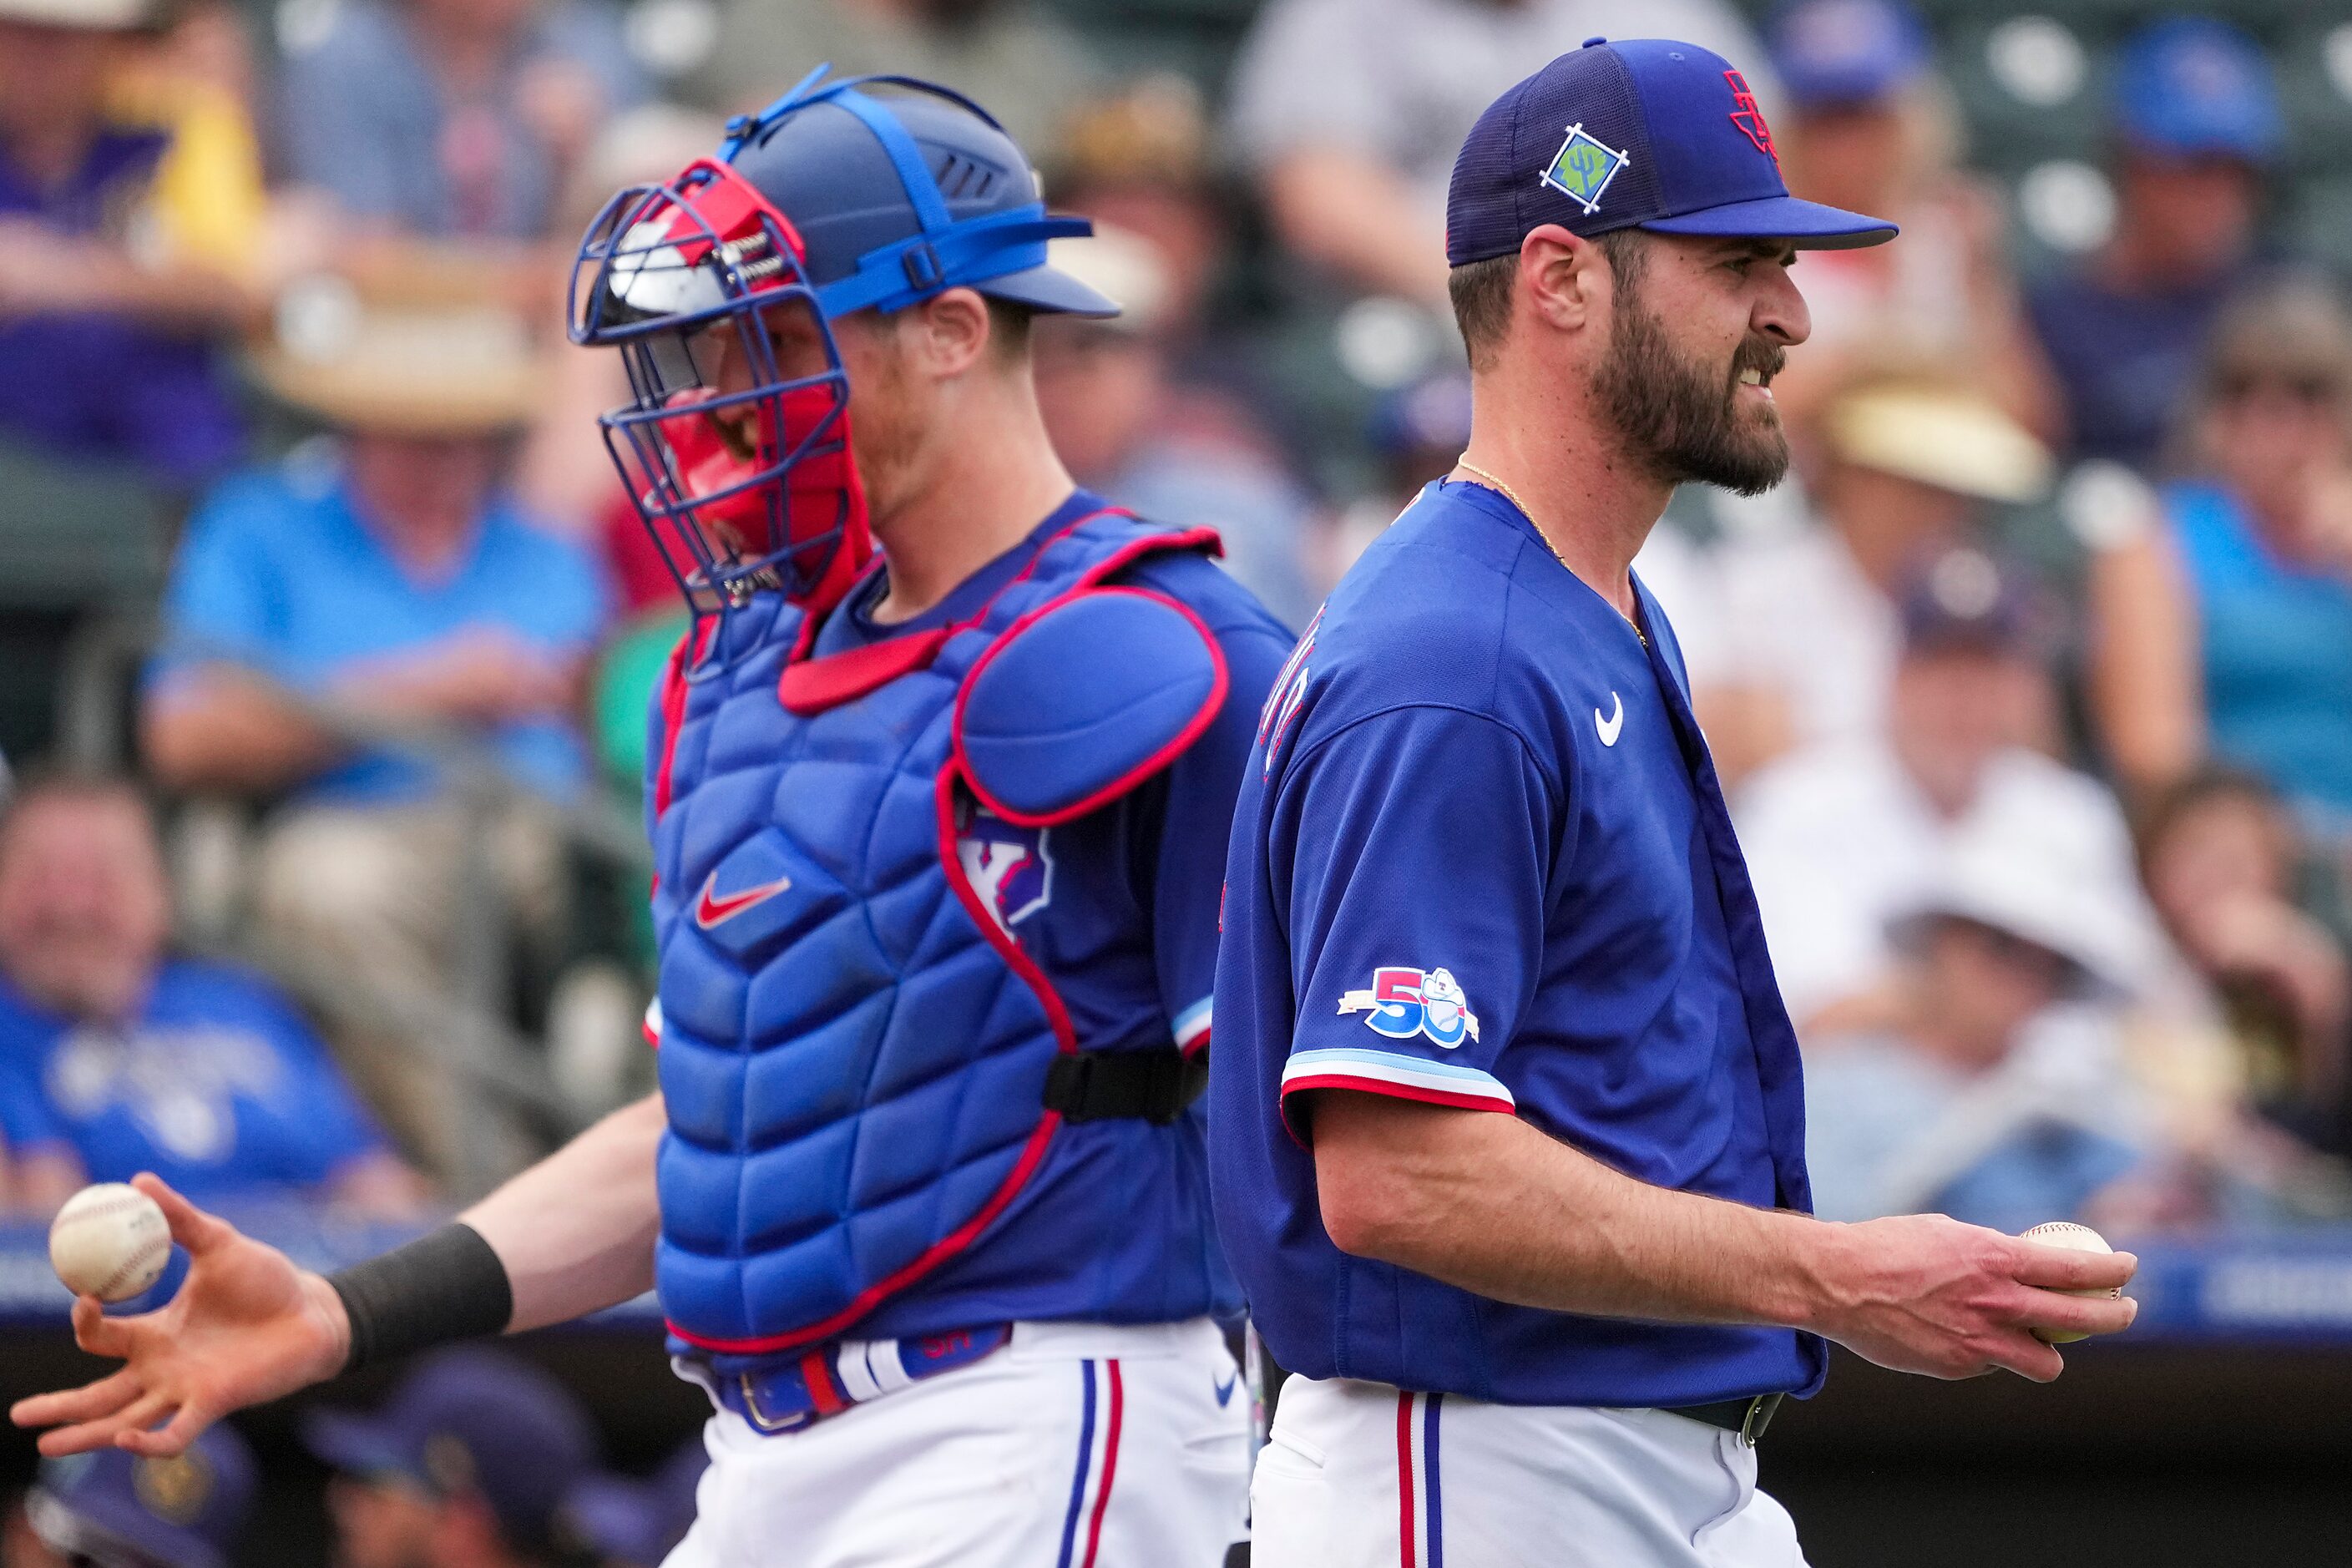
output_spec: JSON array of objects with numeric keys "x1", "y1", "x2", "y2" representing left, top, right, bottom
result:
[{"x1": 651, "y1": 513, "x2": 1226, "y2": 1357}]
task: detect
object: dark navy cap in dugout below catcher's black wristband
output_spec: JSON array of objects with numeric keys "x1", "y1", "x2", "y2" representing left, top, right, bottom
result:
[{"x1": 301, "y1": 1349, "x2": 595, "y2": 1549}]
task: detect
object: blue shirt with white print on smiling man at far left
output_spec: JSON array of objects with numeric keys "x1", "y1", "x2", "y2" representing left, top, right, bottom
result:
[{"x1": 0, "y1": 959, "x2": 383, "y2": 1201}]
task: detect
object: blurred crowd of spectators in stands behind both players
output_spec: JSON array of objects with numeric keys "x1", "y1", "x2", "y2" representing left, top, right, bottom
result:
[{"x1": 0, "y1": 0, "x2": 2352, "y2": 1260}]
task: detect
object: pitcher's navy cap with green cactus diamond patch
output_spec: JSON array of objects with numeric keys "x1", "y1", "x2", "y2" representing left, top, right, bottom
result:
[{"x1": 1446, "y1": 38, "x2": 1896, "y2": 266}]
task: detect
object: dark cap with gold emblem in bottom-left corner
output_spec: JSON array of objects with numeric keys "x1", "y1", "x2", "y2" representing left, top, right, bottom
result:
[{"x1": 23, "y1": 1427, "x2": 254, "y2": 1568}]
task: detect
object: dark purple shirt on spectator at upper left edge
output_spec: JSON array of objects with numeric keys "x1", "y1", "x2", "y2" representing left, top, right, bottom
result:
[{"x1": 0, "y1": 127, "x2": 242, "y2": 484}]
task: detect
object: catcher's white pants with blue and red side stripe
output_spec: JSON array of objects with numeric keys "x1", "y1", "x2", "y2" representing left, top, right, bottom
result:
[{"x1": 663, "y1": 1319, "x2": 1249, "y2": 1568}]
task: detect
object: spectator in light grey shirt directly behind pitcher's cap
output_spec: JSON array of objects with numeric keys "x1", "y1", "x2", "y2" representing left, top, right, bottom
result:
[{"x1": 1232, "y1": 0, "x2": 1778, "y2": 311}]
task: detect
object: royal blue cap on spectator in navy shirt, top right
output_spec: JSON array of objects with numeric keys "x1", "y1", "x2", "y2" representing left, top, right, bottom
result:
[{"x1": 2114, "y1": 17, "x2": 2286, "y2": 162}]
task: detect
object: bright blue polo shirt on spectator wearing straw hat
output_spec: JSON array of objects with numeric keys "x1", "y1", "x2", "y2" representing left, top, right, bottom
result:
[{"x1": 158, "y1": 461, "x2": 607, "y2": 804}]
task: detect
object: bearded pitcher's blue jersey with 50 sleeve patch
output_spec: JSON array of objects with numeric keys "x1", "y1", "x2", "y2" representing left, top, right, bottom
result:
[{"x1": 1209, "y1": 484, "x2": 1825, "y2": 1406}]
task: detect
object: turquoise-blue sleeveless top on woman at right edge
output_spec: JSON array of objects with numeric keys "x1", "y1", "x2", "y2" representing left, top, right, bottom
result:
[{"x1": 2164, "y1": 482, "x2": 2352, "y2": 818}]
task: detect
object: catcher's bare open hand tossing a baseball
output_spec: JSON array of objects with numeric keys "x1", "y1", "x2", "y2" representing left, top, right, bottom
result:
[{"x1": 9, "y1": 1176, "x2": 351, "y2": 1458}]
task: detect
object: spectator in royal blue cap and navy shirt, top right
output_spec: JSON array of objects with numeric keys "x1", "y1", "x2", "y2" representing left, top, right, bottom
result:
[{"x1": 2025, "y1": 17, "x2": 2284, "y2": 470}]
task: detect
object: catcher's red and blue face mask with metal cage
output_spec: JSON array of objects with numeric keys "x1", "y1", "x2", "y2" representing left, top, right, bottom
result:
[{"x1": 567, "y1": 158, "x2": 873, "y2": 646}]
